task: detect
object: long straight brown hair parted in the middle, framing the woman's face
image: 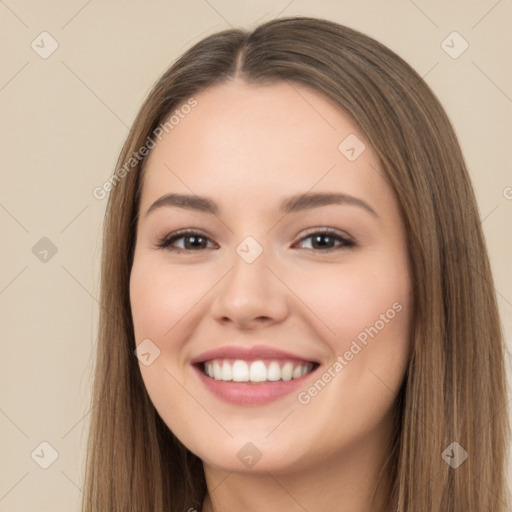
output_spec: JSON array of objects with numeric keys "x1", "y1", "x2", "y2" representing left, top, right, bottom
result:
[{"x1": 83, "y1": 17, "x2": 509, "y2": 512}]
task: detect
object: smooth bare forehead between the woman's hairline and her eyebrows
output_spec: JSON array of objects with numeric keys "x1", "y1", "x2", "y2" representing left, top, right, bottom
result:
[{"x1": 141, "y1": 81, "x2": 391, "y2": 222}]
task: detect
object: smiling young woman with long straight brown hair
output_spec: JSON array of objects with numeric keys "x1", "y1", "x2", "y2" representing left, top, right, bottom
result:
[{"x1": 83, "y1": 18, "x2": 509, "y2": 512}]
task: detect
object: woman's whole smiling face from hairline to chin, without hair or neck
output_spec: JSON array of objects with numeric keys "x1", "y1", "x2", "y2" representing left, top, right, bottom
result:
[{"x1": 130, "y1": 81, "x2": 412, "y2": 473}]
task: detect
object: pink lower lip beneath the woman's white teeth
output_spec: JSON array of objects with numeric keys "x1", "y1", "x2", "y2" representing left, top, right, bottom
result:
[{"x1": 193, "y1": 366, "x2": 318, "y2": 405}]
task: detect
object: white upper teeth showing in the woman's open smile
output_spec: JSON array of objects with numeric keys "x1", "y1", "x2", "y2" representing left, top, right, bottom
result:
[{"x1": 204, "y1": 359, "x2": 313, "y2": 382}]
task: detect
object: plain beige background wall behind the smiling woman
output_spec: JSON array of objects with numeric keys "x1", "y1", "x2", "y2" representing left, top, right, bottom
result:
[{"x1": 0, "y1": 0, "x2": 512, "y2": 512}]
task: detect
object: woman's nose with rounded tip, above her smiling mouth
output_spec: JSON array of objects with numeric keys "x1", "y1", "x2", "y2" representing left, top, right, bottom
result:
[{"x1": 211, "y1": 245, "x2": 290, "y2": 330}]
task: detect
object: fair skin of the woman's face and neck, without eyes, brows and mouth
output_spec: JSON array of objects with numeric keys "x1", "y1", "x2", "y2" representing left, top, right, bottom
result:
[{"x1": 130, "y1": 80, "x2": 412, "y2": 512}]
